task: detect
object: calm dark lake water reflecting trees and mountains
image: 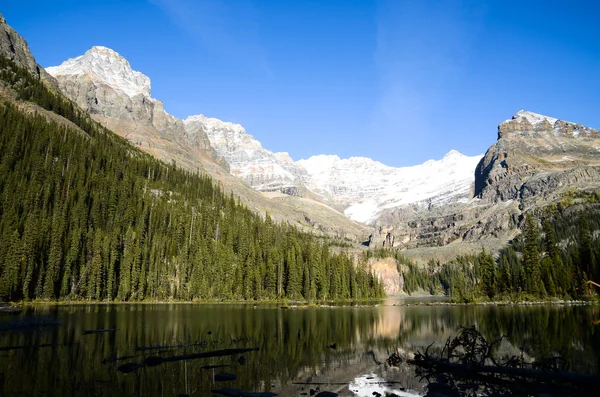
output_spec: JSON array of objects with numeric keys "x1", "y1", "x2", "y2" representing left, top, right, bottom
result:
[{"x1": 0, "y1": 300, "x2": 600, "y2": 396}]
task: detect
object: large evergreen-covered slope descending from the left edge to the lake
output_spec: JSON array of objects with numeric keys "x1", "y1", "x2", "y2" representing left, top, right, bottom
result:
[{"x1": 0, "y1": 58, "x2": 383, "y2": 301}]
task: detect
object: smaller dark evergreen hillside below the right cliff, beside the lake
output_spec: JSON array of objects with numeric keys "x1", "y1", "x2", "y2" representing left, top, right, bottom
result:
[{"x1": 376, "y1": 191, "x2": 600, "y2": 302}]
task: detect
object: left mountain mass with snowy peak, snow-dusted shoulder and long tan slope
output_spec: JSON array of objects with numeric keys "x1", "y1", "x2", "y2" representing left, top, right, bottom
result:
[{"x1": 46, "y1": 46, "x2": 370, "y2": 241}]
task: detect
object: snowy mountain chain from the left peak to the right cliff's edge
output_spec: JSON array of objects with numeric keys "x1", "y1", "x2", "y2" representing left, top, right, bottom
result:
[{"x1": 47, "y1": 46, "x2": 480, "y2": 230}]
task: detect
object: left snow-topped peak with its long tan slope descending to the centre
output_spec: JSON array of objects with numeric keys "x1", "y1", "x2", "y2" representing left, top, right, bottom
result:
[{"x1": 47, "y1": 46, "x2": 370, "y2": 241}]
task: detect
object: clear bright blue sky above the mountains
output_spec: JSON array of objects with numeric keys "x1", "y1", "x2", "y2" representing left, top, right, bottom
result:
[{"x1": 0, "y1": 0, "x2": 600, "y2": 166}]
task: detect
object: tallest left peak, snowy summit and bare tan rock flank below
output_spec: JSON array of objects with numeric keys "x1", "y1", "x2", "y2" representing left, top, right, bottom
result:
[{"x1": 46, "y1": 46, "x2": 216, "y2": 164}]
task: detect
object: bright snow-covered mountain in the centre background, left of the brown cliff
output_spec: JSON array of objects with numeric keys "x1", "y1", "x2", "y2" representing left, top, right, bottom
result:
[{"x1": 297, "y1": 150, "x2": 481, "y2": 224}]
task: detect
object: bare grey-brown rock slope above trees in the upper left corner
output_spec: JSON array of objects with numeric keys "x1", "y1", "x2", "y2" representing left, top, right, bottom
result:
[{"x1": 0, "y1": 14, "x2": 58, "y2": 88}]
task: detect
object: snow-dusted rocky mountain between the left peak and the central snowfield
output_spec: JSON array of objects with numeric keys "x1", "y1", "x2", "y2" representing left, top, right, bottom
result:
[{"x1": 185, "y1": 115, "x2": 306, "y2": 196}]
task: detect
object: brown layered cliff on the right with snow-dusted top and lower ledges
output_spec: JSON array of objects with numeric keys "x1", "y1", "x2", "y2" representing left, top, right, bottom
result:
[{"x1": 370, "y1": 111, "x2": 600, "y2": 248}]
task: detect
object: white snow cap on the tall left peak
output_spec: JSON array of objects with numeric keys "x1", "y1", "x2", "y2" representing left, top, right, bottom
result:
[{"x1": 46, "y1": 46, "x2": 150, "y2": 98}]
